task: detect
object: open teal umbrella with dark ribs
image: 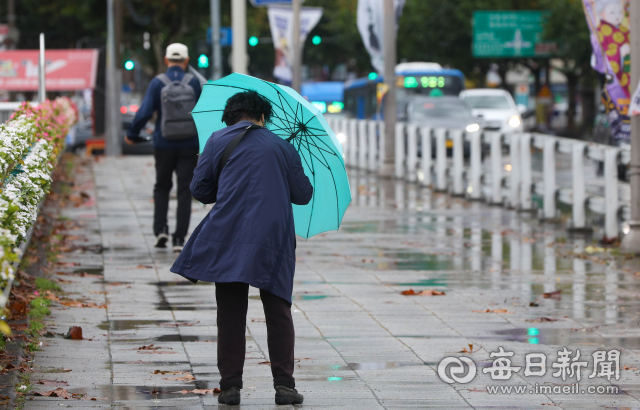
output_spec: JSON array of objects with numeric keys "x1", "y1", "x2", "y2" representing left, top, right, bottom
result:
[{"x1": 191, "y1": 73, "x2": 351, "y2": 238}]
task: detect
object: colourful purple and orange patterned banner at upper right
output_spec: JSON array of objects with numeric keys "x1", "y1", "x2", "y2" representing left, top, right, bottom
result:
[{"x1": 583, "y1": 0, "x2": 631, "y2": 140}]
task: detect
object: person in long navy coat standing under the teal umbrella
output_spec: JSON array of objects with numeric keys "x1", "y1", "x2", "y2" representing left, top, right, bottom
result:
[{"x1": 171, "y1": 91, "x2": 313, "y2": 404}]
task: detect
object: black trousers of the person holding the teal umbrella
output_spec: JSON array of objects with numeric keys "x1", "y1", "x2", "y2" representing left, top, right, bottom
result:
[{"x1": 216, "y1": 282, "x2": 295, "y2": 390}]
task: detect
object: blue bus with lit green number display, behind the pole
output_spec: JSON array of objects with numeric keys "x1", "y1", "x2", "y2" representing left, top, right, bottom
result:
[{"x1": 344, "y1": 62, "x2": 465, "y2": 119}]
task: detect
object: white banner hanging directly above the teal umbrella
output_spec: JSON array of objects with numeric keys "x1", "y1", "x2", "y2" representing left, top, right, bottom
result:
[{"x1": 268, "y1": 7, "x2": 322, "y2": 83}]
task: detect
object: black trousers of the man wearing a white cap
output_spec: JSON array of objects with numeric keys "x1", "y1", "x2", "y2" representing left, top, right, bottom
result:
[{"x1": 153, "y1": 148, "x2": 198, "y2": 239}]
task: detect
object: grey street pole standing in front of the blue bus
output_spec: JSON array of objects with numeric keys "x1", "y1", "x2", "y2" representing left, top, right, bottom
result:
[{"x1": 379, "y1": 0, "x2": 397, "y2": 178}]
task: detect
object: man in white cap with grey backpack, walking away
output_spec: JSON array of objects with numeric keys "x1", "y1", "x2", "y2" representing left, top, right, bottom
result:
[{"x1": 125, "y1": 43, "x2": 202, "y2": 252}]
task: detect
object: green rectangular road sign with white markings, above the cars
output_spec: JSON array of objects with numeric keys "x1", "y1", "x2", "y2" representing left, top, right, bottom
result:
[{"x1": 473, "y1": 11, "x2": 556, "y2": 58}]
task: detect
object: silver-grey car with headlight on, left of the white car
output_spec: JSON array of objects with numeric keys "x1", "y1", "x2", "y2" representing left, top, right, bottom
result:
[{"x1": 400, "y1": 96, "x2": 481, "y2": 158}]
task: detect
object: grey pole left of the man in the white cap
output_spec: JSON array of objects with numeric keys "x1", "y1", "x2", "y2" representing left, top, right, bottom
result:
[{"x1": 105, "y1": 0, "x2": 122, "y2": 155}]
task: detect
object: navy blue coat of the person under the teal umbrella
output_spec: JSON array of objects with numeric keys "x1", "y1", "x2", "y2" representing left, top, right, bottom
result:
[{"x1": 171, "y1": 121, "x2": 313, "y2": 302}]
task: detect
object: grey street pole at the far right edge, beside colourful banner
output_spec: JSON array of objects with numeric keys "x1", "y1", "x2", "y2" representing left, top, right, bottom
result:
[{"x1": 620, "y1": 0, "x2": 640, "y2": 253}]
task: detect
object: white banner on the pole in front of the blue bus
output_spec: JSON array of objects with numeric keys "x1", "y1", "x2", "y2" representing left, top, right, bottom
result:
[{"x1": 357, "y1": 0, "x2": 405, "y2": 74}]
